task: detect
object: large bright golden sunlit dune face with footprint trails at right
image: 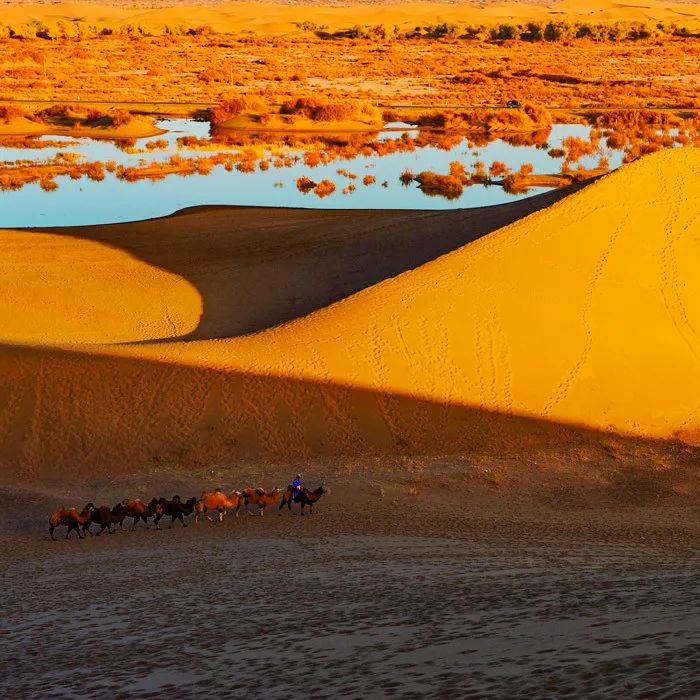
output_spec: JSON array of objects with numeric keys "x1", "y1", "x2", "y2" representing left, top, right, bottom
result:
[{"x1": 144, "y1": 150, "x2": 700, "y2": 437}]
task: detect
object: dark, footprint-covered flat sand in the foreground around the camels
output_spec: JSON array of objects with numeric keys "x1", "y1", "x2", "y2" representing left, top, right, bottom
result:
[{"x1": 0, "y1": 454, "x2": 700, "y2": 699}]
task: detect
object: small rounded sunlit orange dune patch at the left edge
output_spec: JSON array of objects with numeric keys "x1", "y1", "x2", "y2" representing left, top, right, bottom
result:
[{"x1": 0, "y1": 231, "x2": 202, "y2": 343}]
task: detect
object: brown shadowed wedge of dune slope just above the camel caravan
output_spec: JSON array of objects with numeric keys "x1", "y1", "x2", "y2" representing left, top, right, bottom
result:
[{"x1": 0, "y1": 345, "x2": 688, "y2": 483}]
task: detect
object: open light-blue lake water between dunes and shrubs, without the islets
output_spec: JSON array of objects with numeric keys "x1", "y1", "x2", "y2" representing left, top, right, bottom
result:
[{"x1": 0, "y1": 119, "x2": 622, "y2": 227}]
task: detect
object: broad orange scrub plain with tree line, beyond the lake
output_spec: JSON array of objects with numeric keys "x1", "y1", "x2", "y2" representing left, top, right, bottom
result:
[{"x1": 0, "y1": 22, "x2": 700, "y2": 110}]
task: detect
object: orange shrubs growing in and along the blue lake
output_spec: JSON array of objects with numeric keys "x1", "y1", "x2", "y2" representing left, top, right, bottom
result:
[{"x1": 0, "y1": 98, "x2": 700, "y2": 199}]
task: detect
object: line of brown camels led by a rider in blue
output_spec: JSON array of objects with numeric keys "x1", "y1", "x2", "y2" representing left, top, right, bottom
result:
[{"x1": 49, "y1": 482, "x2": 330, "y2": 540}]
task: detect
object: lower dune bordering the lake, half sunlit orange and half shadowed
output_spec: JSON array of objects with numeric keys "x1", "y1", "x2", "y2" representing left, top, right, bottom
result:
[{"x1": 0, "y1": 185, "x2": 581, "y2": 343}]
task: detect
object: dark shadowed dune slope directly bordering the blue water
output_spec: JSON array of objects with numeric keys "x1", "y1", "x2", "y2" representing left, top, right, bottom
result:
[{"x1": 24, "y1": 183, "x2": 586, "y2": 342}]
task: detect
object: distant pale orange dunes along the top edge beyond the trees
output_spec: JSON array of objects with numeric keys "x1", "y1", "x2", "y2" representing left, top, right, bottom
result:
[{"x1": 3, "y1": 0, "x2": 700, "y2": 35}]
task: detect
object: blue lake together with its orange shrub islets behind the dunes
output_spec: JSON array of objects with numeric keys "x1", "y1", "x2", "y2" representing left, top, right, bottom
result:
[{"x1": 0, "y1": 119, "x2": 623, "y2": 227}]
